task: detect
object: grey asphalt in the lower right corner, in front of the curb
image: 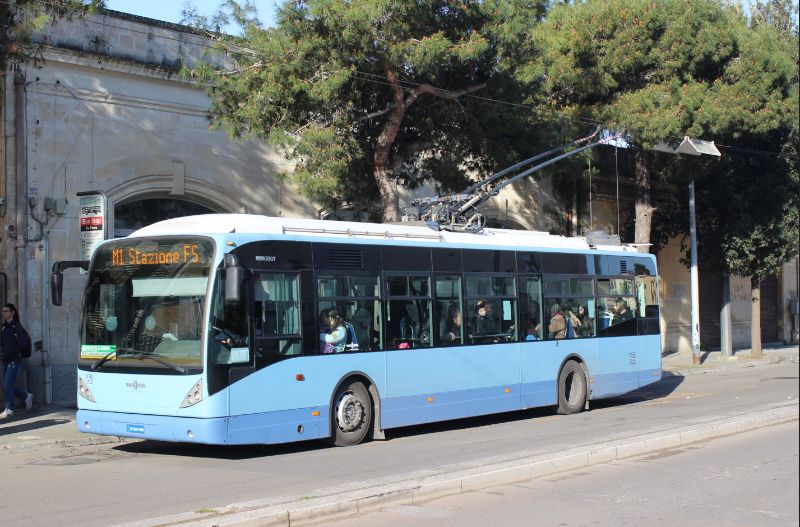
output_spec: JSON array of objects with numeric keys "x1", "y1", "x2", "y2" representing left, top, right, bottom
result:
[{"x1": 326, "y1": 421, "x2": 800, "y2": 527}]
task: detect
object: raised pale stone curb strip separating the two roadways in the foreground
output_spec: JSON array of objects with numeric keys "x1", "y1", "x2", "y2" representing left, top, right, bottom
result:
[{"x1": 124, "y1": 401, "x2": 800, "y2": 527}]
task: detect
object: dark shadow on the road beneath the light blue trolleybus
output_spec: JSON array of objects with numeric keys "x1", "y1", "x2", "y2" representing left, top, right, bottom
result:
[{"x1": 114, "y1": 371, "x2": 684, "y2": 460}]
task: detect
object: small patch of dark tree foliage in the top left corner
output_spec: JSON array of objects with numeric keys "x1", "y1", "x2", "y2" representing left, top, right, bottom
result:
[{"x1": 0, "y1": 0, "x2": 105, "y2": 71}]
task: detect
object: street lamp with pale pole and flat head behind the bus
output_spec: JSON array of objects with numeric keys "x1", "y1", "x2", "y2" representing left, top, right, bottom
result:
[{"x1": 654, "y1": 136, "x2": 730, "y2": 364}]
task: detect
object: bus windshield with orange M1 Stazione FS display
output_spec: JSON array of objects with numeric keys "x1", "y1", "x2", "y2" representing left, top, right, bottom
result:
[{"x1": 78, "y1": 237, "x2": 214, "y2": 375}]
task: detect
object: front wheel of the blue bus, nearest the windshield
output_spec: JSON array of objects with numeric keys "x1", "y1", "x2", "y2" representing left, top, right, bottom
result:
[{"x1": 331, "y1": 381, "x2": 372, "y2": 446}]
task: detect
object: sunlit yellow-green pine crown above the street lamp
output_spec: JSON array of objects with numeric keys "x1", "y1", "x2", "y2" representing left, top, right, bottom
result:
[{"x1": 521, "y1": 0, "x2": 766, "y2": 148}]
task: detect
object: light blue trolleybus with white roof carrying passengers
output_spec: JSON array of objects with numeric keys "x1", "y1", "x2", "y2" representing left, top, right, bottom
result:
[{"x1": 53, "y1": 215, "x2": 661, "y2": 445}]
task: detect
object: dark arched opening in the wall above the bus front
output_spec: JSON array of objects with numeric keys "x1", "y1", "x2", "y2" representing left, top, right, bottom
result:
[{"x1": 114, "y1": 197, "x2": 218, "y2": 238}]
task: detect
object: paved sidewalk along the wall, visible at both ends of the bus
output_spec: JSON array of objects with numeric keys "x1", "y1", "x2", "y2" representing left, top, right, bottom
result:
[{"x1": 0, "y1": 346, "x2": 800, "y2": 455}]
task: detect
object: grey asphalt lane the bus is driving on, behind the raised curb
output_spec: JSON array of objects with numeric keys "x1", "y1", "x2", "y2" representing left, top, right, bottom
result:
[{"x1": 0, "y1": 361, "x2": 798, "y2": 527}]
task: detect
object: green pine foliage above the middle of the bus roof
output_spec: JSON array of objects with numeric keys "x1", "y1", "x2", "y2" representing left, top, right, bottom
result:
[{"x1": 185, "y1": 0, "x2": 545, "y2": 217}]
